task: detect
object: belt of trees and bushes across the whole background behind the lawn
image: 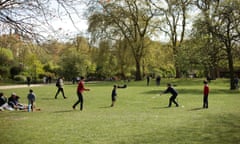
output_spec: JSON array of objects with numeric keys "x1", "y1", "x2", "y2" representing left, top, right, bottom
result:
[{"x1": 0, "y1": 0, "x2": 240, "y2": 89}]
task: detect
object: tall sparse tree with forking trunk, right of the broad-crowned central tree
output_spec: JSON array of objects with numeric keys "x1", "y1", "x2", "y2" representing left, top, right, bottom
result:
[{"x1": 150, "y1": 0, "x2": 192, "y2": 78}]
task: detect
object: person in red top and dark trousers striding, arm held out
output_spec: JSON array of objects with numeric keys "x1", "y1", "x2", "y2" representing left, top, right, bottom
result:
[{"x1": 72, "y1": 77, "x2": 90, "y2": 111}]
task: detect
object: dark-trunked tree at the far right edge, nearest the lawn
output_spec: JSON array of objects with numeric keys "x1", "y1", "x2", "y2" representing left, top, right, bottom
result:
[{"x1": 199, "y1": 0, "x2": 240, "y2": 89}]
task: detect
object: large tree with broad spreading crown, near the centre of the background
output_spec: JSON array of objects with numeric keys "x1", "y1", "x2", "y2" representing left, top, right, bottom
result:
[{"x1": 88, "y1": 0, "x2": 154, "y2": 80}]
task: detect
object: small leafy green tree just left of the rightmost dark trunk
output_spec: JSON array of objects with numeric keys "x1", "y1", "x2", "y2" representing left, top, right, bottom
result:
[{"x1": 190, "y1": 16, "x2": 224, "y2": 79}]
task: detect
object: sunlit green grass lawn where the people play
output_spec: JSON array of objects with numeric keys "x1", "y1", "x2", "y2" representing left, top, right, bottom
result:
[{"x1": 0, "y1": 79, "x2": 240, "y2": 144}]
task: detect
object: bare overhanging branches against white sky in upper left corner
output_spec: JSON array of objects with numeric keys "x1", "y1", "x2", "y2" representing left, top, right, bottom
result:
[{"x1": 0, "y1": 0, "x2": 84, "y2": 39}]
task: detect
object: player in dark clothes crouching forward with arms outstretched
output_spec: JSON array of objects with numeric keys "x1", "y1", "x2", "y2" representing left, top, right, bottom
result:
[{"x1": 160, "y1": 83, "x2": 179, "y2": 107}]
